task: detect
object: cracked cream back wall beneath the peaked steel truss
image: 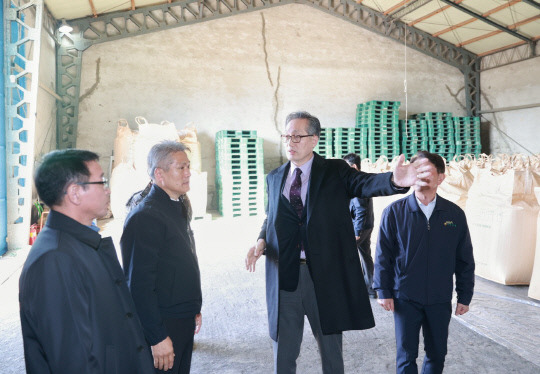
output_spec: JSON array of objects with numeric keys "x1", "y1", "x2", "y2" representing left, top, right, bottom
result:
[{"x1": 77, "y1": 4, "x2": 465, "y2": 208}]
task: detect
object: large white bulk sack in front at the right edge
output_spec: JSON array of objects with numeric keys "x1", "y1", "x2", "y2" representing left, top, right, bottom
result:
[{"x1": 465, "y1": 155, "x2": 540, "y2": 285}]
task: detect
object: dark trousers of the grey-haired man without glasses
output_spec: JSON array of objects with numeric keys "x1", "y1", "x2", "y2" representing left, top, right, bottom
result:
[{"x1": 156, "y1": 317, "x2": 195, "y2": 374}]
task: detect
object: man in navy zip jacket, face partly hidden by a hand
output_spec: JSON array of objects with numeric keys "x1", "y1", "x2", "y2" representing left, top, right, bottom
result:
[{"x1": 373, "y1": 151, "x2": 474, "y2": 374}]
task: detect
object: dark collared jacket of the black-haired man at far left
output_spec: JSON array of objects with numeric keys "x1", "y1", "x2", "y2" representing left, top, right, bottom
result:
[{"x1": 19, "y1": 210, "x2": 154, "y2": 374}]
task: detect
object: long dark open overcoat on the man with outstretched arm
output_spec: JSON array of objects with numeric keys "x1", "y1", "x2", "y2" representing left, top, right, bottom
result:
[{"x1": 259, "y1": 154, "x2": 407, "y2": 340}]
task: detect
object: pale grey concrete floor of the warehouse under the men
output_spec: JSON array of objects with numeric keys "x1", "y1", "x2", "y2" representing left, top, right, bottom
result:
[{"x1": 0, "y1": 215, "x2": 540, "y2": 374}]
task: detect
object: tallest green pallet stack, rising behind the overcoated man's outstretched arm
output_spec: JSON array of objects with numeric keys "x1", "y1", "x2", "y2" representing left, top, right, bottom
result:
[{"x1": 356, "y1": 100, "x2": 401, "y2": 162}]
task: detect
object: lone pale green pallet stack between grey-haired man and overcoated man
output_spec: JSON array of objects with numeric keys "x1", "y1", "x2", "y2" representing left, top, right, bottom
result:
[{"x1": 216, "y1": 130, "x2": 265, "y2": 217}]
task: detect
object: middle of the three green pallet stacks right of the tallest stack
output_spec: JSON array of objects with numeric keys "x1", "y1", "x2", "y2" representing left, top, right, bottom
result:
[{"x1": 412, "y1": 112, "x2": 456, "y2": 161}]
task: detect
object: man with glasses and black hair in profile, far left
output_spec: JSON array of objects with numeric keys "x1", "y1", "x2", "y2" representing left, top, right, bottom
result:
[{"x1": 19, "y1": 149, "x2": 153, "y2": 374}]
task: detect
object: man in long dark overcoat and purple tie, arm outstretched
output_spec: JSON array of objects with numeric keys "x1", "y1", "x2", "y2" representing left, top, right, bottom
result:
[{"x1": 246, "y1": 112, "x2": 435, "y2": 374}]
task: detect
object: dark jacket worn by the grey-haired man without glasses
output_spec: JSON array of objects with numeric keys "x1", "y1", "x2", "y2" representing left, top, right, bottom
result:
[{"x1": 120, "y1": 184, "x2": 202, "y2": 345}]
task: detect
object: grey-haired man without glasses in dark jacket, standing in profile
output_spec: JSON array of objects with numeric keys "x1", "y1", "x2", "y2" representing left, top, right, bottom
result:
[{"x1": 120, "y1": 141, "x2": 202, "y2": 374}]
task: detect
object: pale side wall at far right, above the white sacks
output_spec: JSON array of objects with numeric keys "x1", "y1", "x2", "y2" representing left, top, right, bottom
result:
[{"x1": 480, "y1": 57, "x2": 540, "y2": 154}]
